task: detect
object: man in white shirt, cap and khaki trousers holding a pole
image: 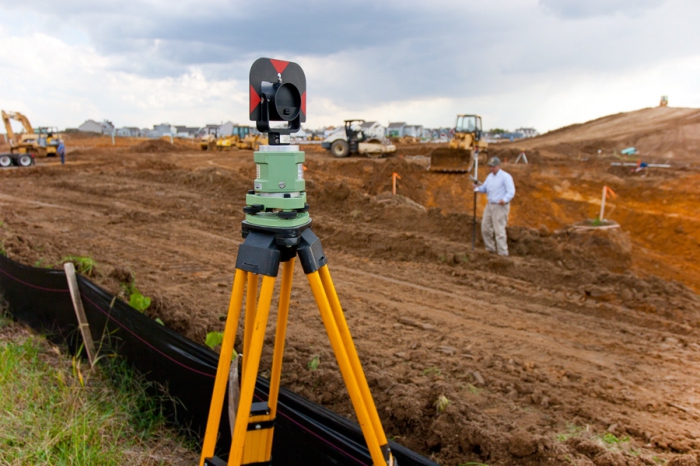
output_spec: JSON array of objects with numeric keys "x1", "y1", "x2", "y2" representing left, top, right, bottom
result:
[{"x1": 474, "y1": 157, "x2": 515, "y2": 256}]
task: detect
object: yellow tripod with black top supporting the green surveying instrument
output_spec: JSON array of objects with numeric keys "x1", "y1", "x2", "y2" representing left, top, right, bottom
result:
[{"x1": 199, "y1": 222, "x2": 398, "y2": 466}]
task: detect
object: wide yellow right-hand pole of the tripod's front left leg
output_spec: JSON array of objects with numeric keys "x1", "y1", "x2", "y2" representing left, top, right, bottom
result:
[{"x1": 228, "y1": 276, "x2": 275, "y2": 466}]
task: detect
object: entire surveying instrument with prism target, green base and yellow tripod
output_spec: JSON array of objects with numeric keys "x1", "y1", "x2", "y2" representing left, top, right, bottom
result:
[{"x1": 199, "y1": 58, "x2": 398, "y2": 466}]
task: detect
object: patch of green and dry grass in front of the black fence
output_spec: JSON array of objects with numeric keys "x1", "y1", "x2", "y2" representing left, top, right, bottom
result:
[{"x1": 0, "y1": 317, "x2": 198, "y2": 465}]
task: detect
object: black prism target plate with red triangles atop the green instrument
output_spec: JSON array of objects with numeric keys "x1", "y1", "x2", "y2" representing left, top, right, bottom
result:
[{"x1": 250, "y1": 58, "x2": 306, "y2": 142}]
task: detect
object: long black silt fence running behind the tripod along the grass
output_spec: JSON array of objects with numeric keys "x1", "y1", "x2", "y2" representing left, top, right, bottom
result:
[{"x1": 0, "y1": 255, "x2": 437, "y2": 466}]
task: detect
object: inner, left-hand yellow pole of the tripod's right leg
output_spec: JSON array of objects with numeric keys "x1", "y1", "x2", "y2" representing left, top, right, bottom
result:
[{"x1": 306, "y1": 270, "x2": 387, "y2": 466}]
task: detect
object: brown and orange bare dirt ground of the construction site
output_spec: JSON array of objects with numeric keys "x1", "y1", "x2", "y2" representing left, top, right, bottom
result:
[{"x1": 0, "y1": 108, "x2": 700, "y2": 465}]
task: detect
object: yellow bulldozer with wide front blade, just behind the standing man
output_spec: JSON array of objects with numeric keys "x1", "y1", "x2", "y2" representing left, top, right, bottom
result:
[{"x1": 428, "y1": 115, "x2": 488, "y2": 173}]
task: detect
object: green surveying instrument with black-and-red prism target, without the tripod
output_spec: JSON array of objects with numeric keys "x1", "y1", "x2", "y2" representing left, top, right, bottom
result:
[{"x1": 243, "y1": 58, "x2": 311, "y2": 233}]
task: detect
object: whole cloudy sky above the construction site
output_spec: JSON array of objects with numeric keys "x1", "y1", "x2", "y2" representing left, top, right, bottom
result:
[{"x1": 0, "y1": 0, "x2": 700, "y2": 132}]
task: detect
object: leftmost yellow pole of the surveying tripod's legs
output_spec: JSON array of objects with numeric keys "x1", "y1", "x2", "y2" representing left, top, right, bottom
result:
[{"x1": 199, "y1": 269, "x2": 249, "y2": 466}]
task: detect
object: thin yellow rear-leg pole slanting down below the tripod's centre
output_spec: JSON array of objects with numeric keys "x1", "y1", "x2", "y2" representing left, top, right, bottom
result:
[{"x1": 266, "y1": 258, "x2": 294, "y2": 458}]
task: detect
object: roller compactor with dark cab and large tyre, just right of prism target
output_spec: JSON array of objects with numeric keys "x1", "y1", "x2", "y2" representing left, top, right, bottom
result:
[{"x1": 321, "y1": 119, "x2": 396, "y2": 157}]
